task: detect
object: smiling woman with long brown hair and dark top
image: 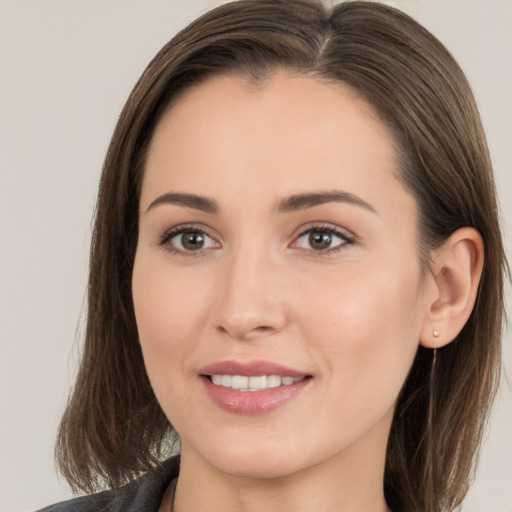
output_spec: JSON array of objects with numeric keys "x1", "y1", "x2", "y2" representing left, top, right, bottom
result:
[{"x1": 37, "y1": 0, "x2": 506, "y2": 512}]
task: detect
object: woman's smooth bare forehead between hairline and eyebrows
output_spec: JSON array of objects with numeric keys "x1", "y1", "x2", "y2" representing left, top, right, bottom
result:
[{"x1": 141, "y1": 72, "x2": 412, "y2": 221}]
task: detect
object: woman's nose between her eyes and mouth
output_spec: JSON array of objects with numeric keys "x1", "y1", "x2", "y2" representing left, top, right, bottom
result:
[{"x1": 214, "y1": 243, "x2": 287, "y2": 341}]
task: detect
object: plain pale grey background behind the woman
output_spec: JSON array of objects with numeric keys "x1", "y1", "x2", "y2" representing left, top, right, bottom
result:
[{"x1": 0, "y1": 0, "x2": 512, "y2": 512}]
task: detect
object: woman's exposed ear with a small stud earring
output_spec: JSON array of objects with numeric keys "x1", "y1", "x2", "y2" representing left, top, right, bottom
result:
[{"x1": 420, "y1": 228, "x2": 484, "y2": 348}]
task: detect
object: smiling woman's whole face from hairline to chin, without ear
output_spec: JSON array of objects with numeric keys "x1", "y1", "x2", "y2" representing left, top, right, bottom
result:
[{"x1": 133, "y1": 73, "x2": 432, "y2": 477}]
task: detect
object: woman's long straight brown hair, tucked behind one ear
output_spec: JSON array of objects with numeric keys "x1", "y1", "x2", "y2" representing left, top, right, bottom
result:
[{"x1": 56, "y1": 0, "x2": 507, "y2": 512}]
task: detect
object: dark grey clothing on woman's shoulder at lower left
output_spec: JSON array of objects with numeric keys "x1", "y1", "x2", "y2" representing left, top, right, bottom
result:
[{"x1": 38, "y1": 457, "x2": 179, "y2": 512}]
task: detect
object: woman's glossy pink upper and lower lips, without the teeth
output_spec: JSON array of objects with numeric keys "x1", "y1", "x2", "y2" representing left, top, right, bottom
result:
[{"x1": 199, "y1": 360, "x2": 312, "y2": 415}]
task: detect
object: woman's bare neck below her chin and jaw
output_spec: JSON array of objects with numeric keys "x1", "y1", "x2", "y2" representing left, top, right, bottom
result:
[{"x1": 174, "y1": 436, "x2": 389, "y2": 512}]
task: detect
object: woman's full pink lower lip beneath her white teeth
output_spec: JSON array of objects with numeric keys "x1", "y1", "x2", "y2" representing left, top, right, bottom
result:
[{"x1": 201, "y1": 377, "x2": 311, "y2": 415}]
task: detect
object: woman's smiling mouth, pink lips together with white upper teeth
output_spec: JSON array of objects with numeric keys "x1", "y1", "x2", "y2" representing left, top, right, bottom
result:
[{"x1": 199, "y1": 361, "x2": 313, "y2": 415}]
